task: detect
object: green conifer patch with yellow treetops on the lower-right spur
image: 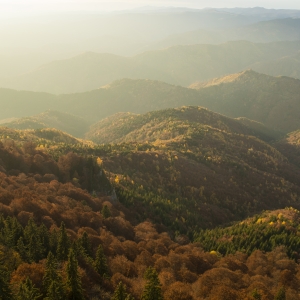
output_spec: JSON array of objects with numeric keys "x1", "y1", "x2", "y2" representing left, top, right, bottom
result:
[{"x1": 195, "y1": 209, "x2": 300, "y2": 259}]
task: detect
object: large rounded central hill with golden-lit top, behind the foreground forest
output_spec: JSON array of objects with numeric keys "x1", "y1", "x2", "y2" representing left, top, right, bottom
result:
[{"x1": 82, "y1": 107, "x2": 300, "y2": 232}]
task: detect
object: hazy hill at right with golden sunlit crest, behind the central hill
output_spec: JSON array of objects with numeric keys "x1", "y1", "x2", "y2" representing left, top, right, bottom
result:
[{"x1": 191, "y1": 70, "x2": 300, "y2": 133}]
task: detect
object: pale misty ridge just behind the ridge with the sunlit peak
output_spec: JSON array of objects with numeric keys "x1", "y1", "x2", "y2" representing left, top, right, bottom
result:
[{"x1": 0, "y1": 41, "x2": 300, "y2": 94}]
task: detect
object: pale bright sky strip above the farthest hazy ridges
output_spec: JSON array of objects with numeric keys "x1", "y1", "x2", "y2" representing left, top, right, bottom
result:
[{"x1": 0, "y1": 0, "x2": 300, "y2": 13}]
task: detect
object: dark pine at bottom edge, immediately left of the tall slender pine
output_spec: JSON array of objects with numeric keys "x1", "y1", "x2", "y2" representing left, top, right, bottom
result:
[{"x1": 43, "y1": 252, "x2": 65, "y2": 300}]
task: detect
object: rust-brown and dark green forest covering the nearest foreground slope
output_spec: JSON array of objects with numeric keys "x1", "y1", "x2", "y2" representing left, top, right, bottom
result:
[{"x1": 0, "y1": 139, "x2": 300, "y2": 300}]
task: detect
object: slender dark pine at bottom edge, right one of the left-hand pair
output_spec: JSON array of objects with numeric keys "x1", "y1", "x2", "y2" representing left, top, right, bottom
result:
[{"x1": 67, "y1": 249, "x2": 84, "y2": 300}]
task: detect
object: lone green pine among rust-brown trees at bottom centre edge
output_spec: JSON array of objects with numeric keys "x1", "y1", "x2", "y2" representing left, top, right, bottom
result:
[{"x1": 142, "y1": 267, "x2": 163, "y2": 300}]
